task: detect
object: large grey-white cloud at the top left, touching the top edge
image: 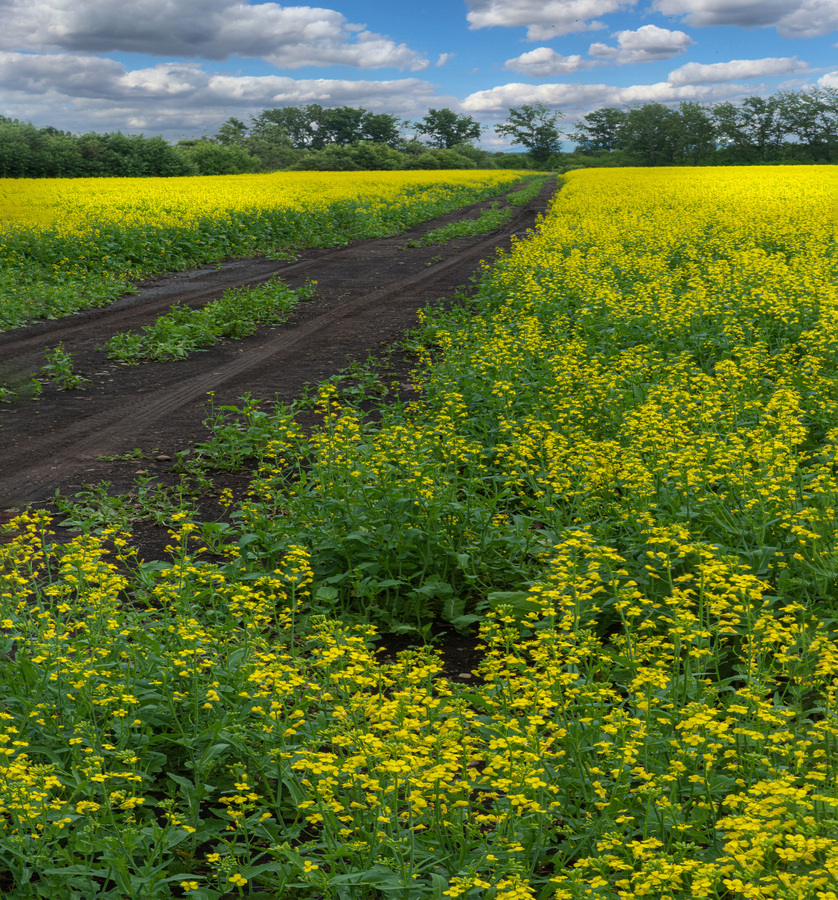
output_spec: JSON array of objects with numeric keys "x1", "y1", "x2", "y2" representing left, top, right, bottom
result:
[{"x1": 0, "y1": 0, "x2": 429, "y2": 70}]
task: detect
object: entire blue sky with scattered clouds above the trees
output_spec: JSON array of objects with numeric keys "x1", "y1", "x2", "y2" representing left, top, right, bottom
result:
[{"x1": 0, "y1": 0, "x2": 838, "y2": 148}]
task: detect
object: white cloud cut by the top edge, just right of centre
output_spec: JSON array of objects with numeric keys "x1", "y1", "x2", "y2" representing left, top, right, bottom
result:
[{"x1": 466, "y1": 0, "x2": 637, "y2": 41}]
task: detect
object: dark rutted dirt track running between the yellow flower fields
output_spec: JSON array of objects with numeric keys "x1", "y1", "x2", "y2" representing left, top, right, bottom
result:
[{"x1": 0, "y1": 184, "x2": 555, "y2": 508}]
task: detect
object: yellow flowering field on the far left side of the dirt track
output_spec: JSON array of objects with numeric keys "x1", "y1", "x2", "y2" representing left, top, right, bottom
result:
[{"x1": 0, "y1": 172, "x2": 520, "y2": 331}]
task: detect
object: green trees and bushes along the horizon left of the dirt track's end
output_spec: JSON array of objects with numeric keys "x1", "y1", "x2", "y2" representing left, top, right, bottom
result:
[{"x1": 0, "y1": 104, "x2": 492, "y2": 178}]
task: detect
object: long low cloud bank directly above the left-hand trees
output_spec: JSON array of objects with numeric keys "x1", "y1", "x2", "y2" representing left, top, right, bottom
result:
[{"x1": 0, "y1": 52, "x2": 440, "y2": 136}]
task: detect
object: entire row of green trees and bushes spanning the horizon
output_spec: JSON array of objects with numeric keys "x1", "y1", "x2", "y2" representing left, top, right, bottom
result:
[{"x1": 0, "y1": 88, "x2": 838, "y2": 178}]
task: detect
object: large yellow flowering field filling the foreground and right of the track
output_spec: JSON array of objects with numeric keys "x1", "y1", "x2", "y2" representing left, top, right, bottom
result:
[{"x1": 0, "y1": 167, "x2": 838, "y2": 900}]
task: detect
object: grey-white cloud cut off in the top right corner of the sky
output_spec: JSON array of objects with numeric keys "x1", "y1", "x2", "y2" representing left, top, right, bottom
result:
[{"x1": 652, "y1": 0, "x2": 838, "y2": 38}]
